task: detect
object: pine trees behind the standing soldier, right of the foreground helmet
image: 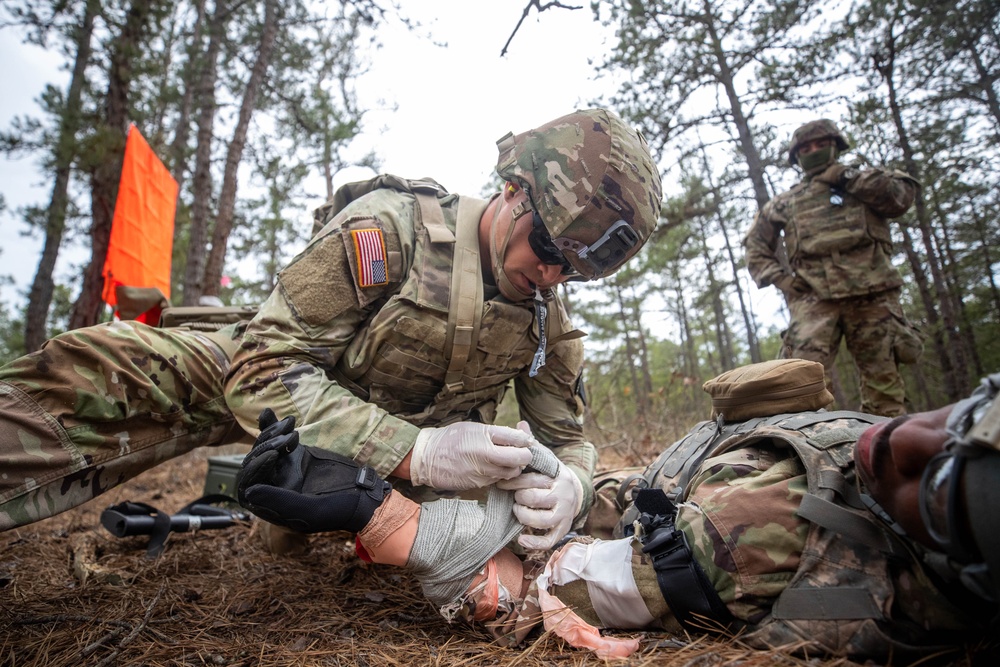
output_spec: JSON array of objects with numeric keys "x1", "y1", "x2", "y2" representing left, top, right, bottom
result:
[{"x1": 587, "y1": 0, "x2": 1000, "y2": 428}]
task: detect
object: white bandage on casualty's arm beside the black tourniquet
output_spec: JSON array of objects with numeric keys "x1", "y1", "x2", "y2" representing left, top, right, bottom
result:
[{"x1": 538, "y1": 538, "x2": 655, "y2": 630}]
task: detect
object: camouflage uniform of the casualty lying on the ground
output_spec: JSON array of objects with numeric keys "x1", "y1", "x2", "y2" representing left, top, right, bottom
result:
[{"x1": 467, "y1": 412, "x2": 995, "y2": 658}]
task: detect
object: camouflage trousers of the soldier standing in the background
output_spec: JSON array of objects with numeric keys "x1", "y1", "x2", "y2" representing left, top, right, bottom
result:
[{"x1": 785, "y1": 290, "x2": 906, "y2": 417}]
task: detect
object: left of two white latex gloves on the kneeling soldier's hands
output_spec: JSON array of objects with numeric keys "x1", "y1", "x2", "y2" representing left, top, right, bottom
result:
[{"x1": 410, "y1": 422, "x2": 533, "y2": 491}]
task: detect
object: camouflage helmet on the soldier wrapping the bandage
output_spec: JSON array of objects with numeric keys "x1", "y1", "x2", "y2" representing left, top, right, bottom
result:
[{"x1": 497, "y1": 109, "x2": 663, "y2": 280}]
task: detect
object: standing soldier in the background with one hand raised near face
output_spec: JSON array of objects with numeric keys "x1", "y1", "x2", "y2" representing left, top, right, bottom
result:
[{"x1": 744, "y1": 119, "x2": 922, "y2": 417}]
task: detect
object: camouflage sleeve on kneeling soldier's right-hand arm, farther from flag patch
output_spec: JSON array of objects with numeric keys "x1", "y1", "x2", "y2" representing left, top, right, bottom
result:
[{"x1": 514, "y1": 338, "x2": 597, "y2": 518}]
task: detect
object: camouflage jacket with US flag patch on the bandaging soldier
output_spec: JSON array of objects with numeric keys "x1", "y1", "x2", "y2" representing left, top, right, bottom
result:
[{"x1": 227, "y1": 188, "x2": 596, "y2": 510}]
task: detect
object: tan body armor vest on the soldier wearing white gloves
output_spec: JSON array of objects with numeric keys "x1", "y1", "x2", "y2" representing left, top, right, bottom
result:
[{"x1": 300, "y1": 176, "x2": 583, "y2": 426}]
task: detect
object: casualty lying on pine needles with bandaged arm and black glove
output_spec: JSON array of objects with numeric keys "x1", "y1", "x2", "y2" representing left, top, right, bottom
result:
[{"x1": 238, "y1": 360, "x2": 1000, "y2": 659}]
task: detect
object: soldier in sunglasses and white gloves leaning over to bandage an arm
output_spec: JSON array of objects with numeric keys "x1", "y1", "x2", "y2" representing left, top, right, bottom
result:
[{"x1": 0, "y1": 109, "x2": 661, "y2": 547}]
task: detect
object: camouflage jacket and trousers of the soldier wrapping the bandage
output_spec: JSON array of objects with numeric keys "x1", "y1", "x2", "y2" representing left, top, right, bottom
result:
[{"x1": 0, "y1": 189, "x2": 596, "y2": 530}]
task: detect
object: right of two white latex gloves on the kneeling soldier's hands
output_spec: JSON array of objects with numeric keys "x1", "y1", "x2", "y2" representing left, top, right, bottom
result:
[{"x1": 497, "y1": 462, "x2": 583, "y2": 550}]
